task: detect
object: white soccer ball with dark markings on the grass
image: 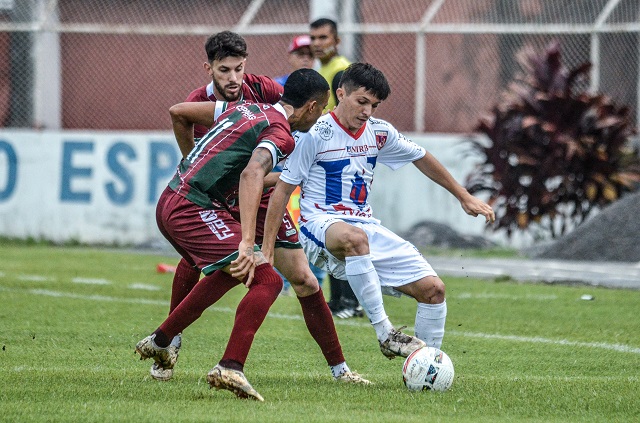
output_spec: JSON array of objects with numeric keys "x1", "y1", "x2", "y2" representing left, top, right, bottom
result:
[{"x1": 402, "y1": 347, "x2": 453, "y2": 391}]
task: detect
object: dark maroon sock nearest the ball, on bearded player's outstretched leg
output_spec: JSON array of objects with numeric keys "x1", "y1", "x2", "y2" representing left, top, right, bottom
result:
[{"x1": 298, "y1": 288, "x2": 345, "y2": 366}]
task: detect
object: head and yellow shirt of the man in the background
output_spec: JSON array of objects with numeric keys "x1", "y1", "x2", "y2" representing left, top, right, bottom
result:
[{"x1": 309, "y1": 18, "x2": 351, "y2": 112}]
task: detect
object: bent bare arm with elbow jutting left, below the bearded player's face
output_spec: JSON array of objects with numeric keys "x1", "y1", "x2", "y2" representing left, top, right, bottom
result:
[{"x1": 169, "y1": 101, "x2": 215, "y2": 157}]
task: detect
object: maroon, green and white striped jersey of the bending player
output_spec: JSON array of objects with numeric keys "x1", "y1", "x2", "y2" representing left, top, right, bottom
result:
[{"x1": 169, "y1": 102, "x2": 295, "y2": 208}]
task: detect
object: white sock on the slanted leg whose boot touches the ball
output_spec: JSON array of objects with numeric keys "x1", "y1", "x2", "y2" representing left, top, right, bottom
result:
[{"x1": 345, "y1": 254, "x2": 393, "y2": 341}]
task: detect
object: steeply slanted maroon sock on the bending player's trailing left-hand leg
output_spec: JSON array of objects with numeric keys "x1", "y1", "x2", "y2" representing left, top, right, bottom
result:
[{"x1": 158, "y1": 270, "x2": 240, "y2": 339}]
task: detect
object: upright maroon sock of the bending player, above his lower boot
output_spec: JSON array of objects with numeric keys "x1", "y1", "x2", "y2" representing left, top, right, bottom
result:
[{"x1": 220, "y1": 264, "x2": 282, "y2": 365}]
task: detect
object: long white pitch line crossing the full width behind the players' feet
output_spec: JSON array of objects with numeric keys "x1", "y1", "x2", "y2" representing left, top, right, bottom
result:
[{"x1": 0, "y1": 286, "x2": 640, "y2": 354}]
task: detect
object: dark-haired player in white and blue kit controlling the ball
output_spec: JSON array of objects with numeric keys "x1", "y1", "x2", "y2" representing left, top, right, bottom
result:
[{"x1": 262, "y1": 63, "x2": 495, "y2": 358}]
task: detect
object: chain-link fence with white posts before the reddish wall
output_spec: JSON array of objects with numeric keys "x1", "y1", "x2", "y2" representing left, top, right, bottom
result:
[{"x1": 0, "y1": 0, "x2": 640, "y2": 133}]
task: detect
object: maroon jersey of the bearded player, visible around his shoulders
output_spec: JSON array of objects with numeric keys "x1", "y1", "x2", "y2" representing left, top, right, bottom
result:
[{"x1": 185, "y1": 73, "x2": 283, "y2": 138}]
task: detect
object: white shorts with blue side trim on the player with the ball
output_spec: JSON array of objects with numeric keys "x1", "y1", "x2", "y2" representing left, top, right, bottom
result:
[{"x1": 299, "y1": 215, "x2": 437, "y2": 295}]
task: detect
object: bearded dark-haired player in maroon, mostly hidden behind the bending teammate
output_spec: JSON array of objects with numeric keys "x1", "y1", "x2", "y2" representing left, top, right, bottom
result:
[{"x1": 151, "y1": 31, "x2": 369, "y2": 390}]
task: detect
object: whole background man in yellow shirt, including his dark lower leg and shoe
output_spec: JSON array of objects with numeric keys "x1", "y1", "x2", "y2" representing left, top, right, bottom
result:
[{"x1": 309, "y1": 18, "x2": 364, "y2": 319}]
